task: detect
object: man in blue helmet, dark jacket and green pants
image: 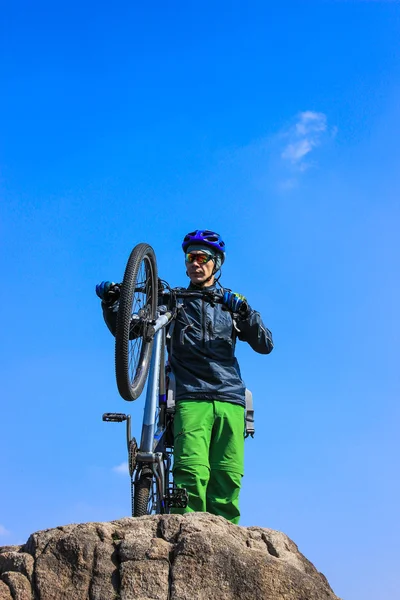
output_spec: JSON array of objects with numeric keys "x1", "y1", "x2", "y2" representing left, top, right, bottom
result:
[{"x1": 97, "y1": 229, "x2": 273, "y2": 523}]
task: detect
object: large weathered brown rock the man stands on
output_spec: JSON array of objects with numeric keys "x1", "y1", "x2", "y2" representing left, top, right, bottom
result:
[{"x1": 0, "y1": 513, "x2": 339, "y2": 600}]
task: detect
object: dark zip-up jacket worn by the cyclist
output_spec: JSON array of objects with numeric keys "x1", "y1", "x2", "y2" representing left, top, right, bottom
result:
[{"x1": 102, "y1": 286, "x2": 273, "y2": 406}]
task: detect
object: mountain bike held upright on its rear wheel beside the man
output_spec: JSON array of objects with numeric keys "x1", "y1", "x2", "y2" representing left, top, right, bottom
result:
[{"x1": 103, "y1": 243, "x2": 254, "y2": 517}]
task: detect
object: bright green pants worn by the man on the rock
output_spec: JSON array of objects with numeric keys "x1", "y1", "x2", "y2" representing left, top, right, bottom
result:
[{"x1": 173, "y1": 400, "x2": 245, "y2": 523}]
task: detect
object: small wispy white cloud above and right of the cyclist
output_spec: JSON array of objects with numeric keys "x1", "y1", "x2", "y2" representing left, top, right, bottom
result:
[{"x1": 281, "y1": 110, "x2": 327, "y2": 171}]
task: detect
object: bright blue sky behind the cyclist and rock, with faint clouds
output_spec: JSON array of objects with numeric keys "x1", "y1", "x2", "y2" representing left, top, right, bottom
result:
[{"x1": 0, "y1": 0, "x2": 400, "y2": 600}]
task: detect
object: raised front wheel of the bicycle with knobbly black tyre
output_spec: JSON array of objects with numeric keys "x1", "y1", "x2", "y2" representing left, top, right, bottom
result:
[{"x1": 115, "y1": 243, "x2": 158, "y2": 401}]
